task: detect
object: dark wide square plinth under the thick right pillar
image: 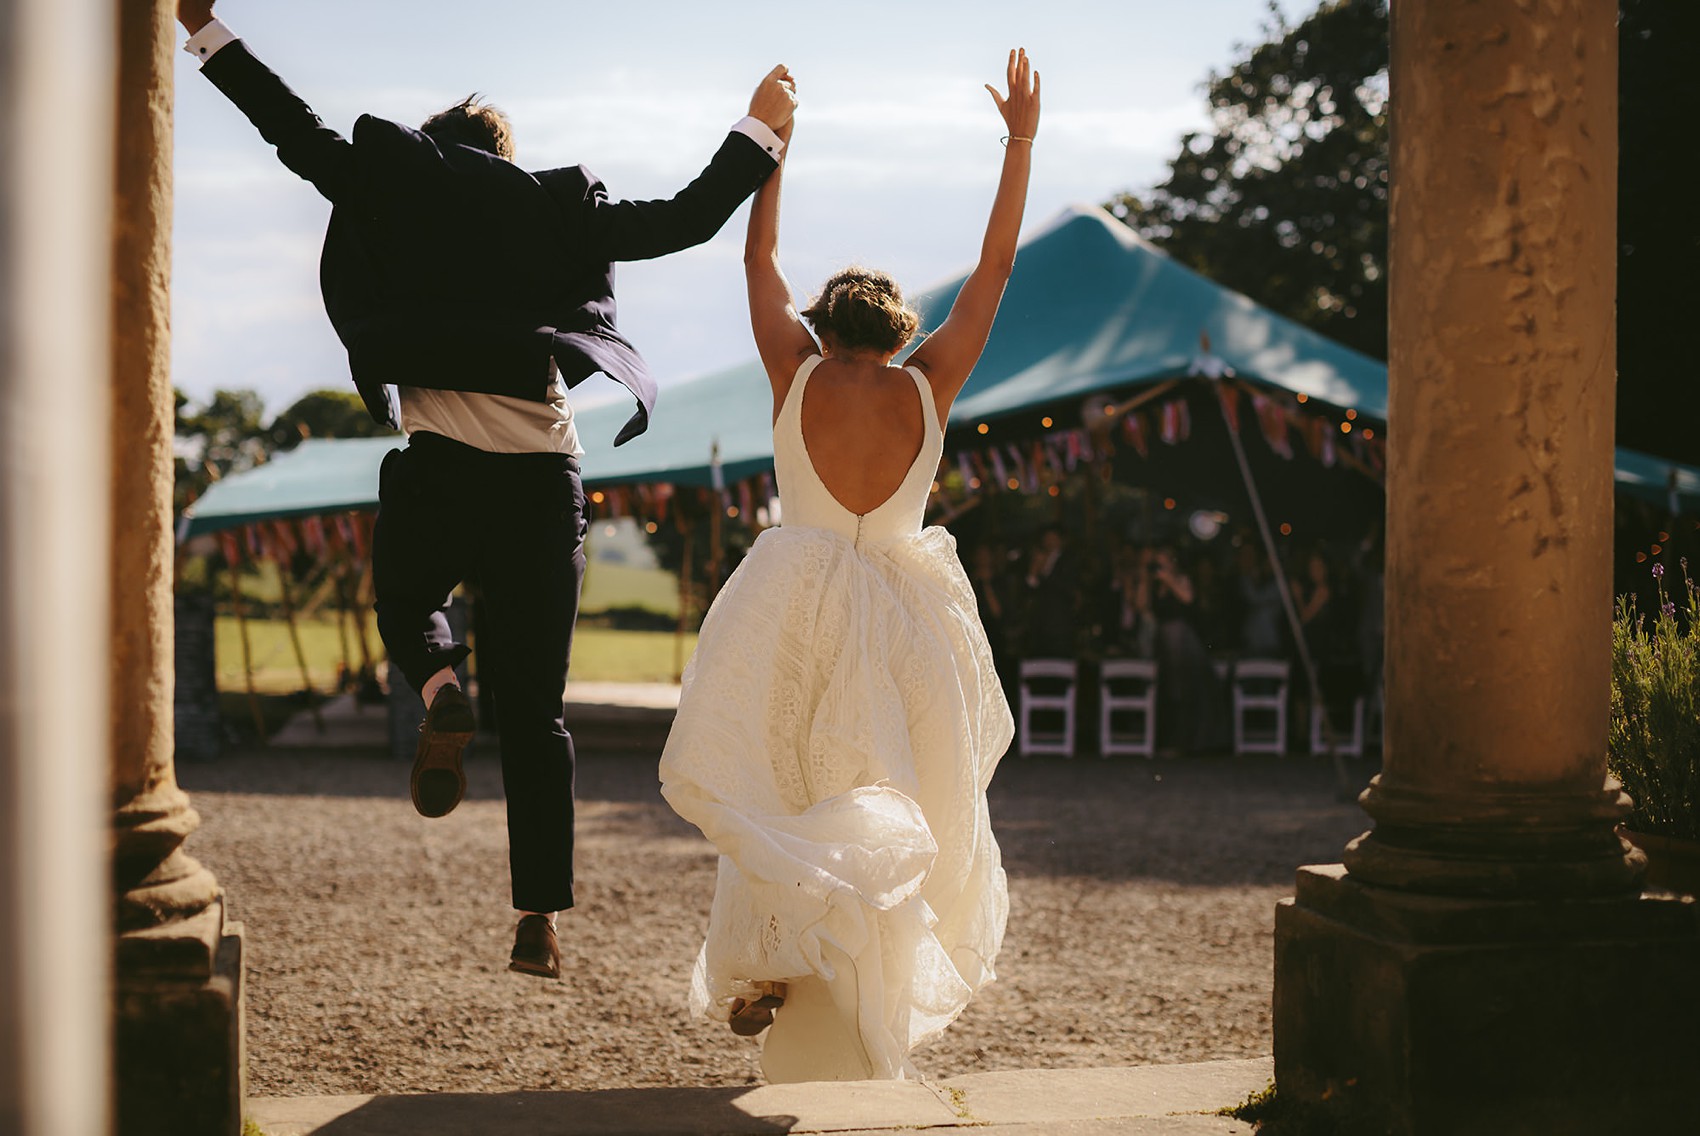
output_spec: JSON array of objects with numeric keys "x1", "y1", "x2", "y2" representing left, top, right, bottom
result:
[{"x1": 1275, "y1": 864, "x2": 1700, "y2": 1136}]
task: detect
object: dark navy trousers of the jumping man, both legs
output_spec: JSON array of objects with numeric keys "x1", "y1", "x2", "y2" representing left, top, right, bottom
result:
[{"x1": 372, "y1": 432, "x2": 588, "y2": 912}]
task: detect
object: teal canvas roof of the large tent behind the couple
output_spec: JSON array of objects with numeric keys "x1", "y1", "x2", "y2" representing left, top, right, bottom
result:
[{"x1": 185, "y1": 207, "x2": 1700, "y2": 536}]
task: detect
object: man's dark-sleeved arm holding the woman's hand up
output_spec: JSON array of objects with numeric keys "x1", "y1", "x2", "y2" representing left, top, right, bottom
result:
[{"x1": 564, "y1": 65, "x2": 797, "y2": 260}]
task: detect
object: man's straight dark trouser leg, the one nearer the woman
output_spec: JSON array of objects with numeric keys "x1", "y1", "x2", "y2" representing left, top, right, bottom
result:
[{"x1": 476, "y1": 454, "x2": 587, "y2": 912}]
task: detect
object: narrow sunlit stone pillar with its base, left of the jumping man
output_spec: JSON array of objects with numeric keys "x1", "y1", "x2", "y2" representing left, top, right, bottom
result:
[{"x1": 111, "y1": 0, "x2": 243, "y2": 1136}]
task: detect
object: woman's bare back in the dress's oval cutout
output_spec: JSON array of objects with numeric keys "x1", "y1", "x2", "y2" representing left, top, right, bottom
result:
[{"x1": 801, "y1": 357, "x2": 925, "y2": 514}]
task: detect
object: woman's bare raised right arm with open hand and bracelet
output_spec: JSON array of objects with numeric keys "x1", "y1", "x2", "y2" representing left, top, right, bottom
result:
[{"x1": 910, "y1": 48, "x2": 1039, "y2": 410}]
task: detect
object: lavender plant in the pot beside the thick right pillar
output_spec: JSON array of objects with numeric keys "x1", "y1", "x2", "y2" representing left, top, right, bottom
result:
[{"x1": 1607, "y1": 559, "x2": 1700, "y2": 840}]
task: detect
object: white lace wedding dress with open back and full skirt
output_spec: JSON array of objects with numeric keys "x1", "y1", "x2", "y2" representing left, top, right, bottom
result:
[{"x1": 661, "y1": 355, "x2": 1013, "y2": 1082}]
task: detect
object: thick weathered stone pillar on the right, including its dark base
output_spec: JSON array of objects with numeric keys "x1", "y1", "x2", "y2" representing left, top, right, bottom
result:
[{"x1": 1275, "y1": 0, "x2": 1700, "y2": 1136}]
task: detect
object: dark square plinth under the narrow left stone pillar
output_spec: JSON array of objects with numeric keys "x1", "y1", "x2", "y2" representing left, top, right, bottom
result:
[{"x1": 114, "y1": 901, "x2": 248, "y2": 1136}]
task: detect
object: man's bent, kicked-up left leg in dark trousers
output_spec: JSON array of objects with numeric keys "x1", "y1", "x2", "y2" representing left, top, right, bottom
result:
[{"x1": 372, "y1": 435, "x2": 469, "y2": 690}]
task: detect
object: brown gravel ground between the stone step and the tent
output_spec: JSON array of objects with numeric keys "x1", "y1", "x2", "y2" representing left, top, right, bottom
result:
[{"x1": 179, "y1": 736, "x2": 1374, "y2": 1095}]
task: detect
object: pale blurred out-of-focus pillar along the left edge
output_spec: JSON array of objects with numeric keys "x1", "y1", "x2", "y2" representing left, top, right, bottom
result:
[{"x1": 0, "y1": 0, "x2": 114, "y2": 1136}]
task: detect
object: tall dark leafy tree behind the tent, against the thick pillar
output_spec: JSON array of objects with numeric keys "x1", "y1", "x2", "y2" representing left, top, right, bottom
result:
[{"x1": 1108, "y1": 0, "x2": 1387, "y2": 359}]
